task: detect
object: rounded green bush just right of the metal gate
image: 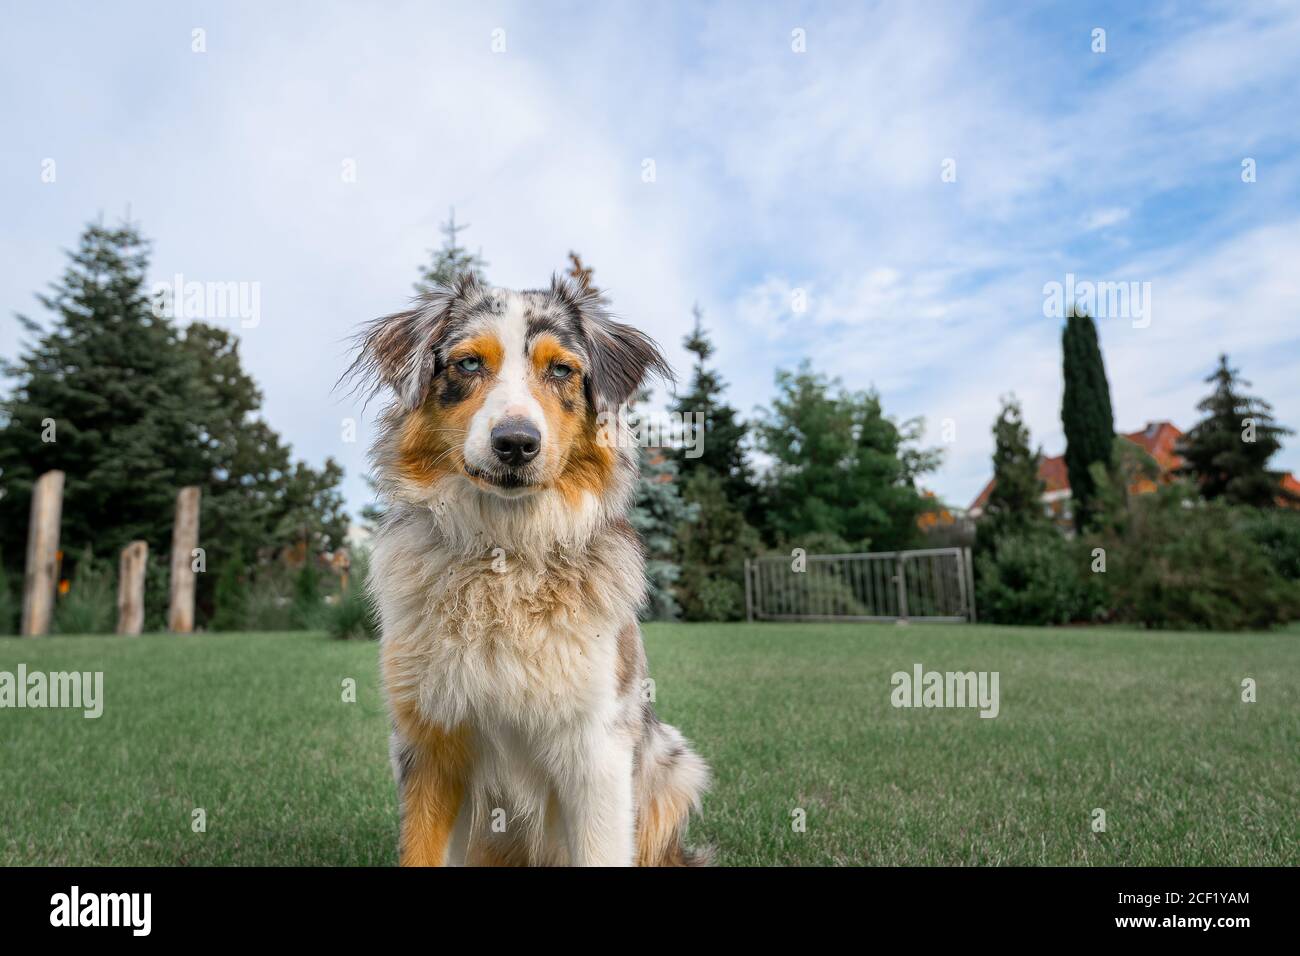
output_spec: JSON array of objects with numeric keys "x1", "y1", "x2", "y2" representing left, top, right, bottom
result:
[{"x1": 975, "y1": 527, "x2": 1102, "y2": 624}]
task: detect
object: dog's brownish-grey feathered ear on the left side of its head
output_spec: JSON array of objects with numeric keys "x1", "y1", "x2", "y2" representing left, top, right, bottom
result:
[{"x1": 339, "y1": 274, "x2": 485, "y2": 411}]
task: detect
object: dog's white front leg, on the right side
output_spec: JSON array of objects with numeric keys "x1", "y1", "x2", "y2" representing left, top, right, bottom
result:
[{"x1": 558, "y1": 734, "x2": 636, "y2": 866}]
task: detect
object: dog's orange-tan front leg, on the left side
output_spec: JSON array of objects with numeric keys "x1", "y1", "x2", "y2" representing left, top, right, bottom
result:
[{"x1": 394, "y1": 724, "x2": 469, "y2": 866}]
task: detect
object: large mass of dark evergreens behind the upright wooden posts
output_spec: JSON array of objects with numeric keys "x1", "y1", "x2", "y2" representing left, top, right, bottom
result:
[{"x1": 0, "y1": 222, "x2": 347, "y2": 629}]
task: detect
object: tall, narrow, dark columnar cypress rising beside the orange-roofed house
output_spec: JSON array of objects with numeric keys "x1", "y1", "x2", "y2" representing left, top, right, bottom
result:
[{"x1": 1061, "y1": 311, "x2": 1115, "y2": 531}]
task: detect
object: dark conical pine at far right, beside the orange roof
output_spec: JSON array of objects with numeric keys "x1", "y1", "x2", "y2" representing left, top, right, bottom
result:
[{"x1": 1178, "y1": 355, "x2": 1295, "y2": 507}]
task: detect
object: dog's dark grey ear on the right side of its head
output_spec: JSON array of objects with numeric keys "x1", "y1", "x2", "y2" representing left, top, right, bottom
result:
[{"x1": 551, "y1": 274, "x2": 673, "y2": 411}]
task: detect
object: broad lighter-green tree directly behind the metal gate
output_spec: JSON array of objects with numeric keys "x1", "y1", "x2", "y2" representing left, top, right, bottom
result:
[{"x1": 757, "y1": 360, "x2": 940, "y2": 550}]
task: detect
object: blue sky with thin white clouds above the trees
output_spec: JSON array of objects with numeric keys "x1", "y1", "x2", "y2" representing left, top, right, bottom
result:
[{"x1": 0, "y1": 0, "x2": 1300, "y2": 514}]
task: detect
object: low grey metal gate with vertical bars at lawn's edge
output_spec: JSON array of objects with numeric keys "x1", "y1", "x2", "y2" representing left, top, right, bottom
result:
[{"x1": 745, "y1": 548, "x2": 975, "y2": 622}]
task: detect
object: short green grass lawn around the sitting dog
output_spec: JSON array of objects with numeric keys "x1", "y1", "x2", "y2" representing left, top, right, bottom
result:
[{"x1": 0, "y1": 624, "x2": 1300, "y2": 865}]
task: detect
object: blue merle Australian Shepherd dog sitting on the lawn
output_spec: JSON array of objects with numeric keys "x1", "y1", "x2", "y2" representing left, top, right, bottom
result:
[{"x1": 351, "y1": 270, "x2": 709, "y2": 866}]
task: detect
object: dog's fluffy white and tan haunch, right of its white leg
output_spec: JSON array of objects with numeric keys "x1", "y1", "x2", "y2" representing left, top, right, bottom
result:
[{"x1": 637, "y1": 706, "x2": 712, "y2": 866}]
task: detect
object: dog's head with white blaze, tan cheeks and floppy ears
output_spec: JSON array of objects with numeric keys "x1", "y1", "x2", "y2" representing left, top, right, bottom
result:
[{"x1": 352, "y1": 276, "x2": 671, "y2": 499}]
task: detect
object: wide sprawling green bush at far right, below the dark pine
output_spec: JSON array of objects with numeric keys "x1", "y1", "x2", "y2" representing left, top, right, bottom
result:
[{"x1": 1089, "y1": 485, "x2": 1300, "y2": 631}]
